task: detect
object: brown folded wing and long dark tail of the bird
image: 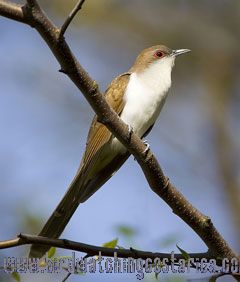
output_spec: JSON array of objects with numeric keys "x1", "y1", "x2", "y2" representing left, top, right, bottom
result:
[{"x1": 30, "y1": 73, "x2": 130, "y2": 257}]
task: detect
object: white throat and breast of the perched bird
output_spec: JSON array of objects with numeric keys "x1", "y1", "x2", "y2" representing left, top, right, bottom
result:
[{"x1": 112, "y1": 57, "x2": 174, "y2": 152}]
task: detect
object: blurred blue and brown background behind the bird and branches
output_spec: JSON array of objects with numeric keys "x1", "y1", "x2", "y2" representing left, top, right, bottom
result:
[{"x1": 0, "y1": 0, "x2": 240, "y2": 281}]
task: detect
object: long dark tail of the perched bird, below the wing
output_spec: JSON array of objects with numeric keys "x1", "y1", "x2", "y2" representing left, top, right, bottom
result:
[{"x1": 29, "y1": 152, "x2": 129, "y2": 258}]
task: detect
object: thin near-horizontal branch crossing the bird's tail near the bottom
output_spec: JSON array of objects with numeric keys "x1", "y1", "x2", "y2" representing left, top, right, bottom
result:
[{"x1": 0, "y1": 234, "x2": 210, "y2": 260}]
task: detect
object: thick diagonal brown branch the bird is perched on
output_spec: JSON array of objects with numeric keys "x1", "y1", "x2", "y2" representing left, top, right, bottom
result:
[{"x1": 0, "y1": 0, "x2": 237, "y2": 258}]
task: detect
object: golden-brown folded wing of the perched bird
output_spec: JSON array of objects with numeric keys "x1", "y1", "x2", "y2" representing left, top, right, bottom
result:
[{"x1": 80, "y1": 73, "x2": 130, "y2": 168}]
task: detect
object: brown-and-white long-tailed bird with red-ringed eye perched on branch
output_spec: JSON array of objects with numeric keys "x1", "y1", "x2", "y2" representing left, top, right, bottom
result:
[{"x1": 29, "y1": 45, "x2": 190, "y2": 258}]
